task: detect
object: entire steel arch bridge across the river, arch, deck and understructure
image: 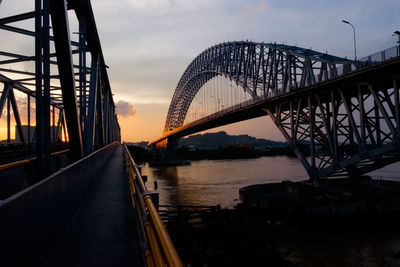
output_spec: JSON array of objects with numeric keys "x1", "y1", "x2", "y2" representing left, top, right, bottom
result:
[{"x1": 150, "y1": 42, "x2": 400, "y2": 178}]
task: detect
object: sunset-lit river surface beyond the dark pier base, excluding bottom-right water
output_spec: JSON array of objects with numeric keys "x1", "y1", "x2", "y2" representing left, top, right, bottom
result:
[{"x1": 142, "y1": 156, "x2": 400, "y2": 208}]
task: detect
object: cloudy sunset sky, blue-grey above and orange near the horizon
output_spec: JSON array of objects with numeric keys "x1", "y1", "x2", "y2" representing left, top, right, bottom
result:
[{"x1": 0, "y1": 0, "x2": 400, "y2": 142}]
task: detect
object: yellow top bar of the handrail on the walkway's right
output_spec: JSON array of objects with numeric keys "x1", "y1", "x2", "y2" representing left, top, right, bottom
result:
[{"x1": 123, "y1": 142, "x2": 183, "y2": 267}]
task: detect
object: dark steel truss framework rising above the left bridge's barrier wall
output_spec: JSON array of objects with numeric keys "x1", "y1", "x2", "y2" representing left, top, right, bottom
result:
[{"x1": 0, "y1": 0, "x2": 120, "y2": 177}]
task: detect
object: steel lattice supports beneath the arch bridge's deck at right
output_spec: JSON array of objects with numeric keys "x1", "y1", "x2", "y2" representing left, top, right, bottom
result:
[{"x1": 264, "y1": 70, "x2": 400, "y2": 178}]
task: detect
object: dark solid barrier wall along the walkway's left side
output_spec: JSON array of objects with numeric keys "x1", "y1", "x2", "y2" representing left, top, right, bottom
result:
[{"x1": 0, "y1": 142, "x2": 120, "y2": 266}]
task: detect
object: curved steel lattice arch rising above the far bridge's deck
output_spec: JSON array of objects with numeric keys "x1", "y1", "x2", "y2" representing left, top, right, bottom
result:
[{"x1": 164, "y1": 42, "x2": 354, "y2": 133}]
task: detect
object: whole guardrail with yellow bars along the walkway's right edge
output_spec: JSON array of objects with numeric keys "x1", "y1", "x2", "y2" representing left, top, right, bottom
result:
[{"x1": 123, "y1": 143, "x2": 183, "y2": 267}]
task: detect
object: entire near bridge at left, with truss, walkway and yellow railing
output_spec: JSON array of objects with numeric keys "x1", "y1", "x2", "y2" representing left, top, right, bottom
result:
[{"x1": 0, "y1": 3, "x2": 182, "y2": 267}]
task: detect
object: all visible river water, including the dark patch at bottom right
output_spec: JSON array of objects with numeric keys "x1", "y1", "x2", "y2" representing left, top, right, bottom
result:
[{"x1": 142, "y1": 156, "x2": 400, "y2": 267}]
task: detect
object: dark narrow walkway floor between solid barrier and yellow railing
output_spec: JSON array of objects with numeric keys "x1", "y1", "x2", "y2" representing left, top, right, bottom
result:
[{"x1": 46, "y1": 146, "x2": 143, "y2": 266}]
